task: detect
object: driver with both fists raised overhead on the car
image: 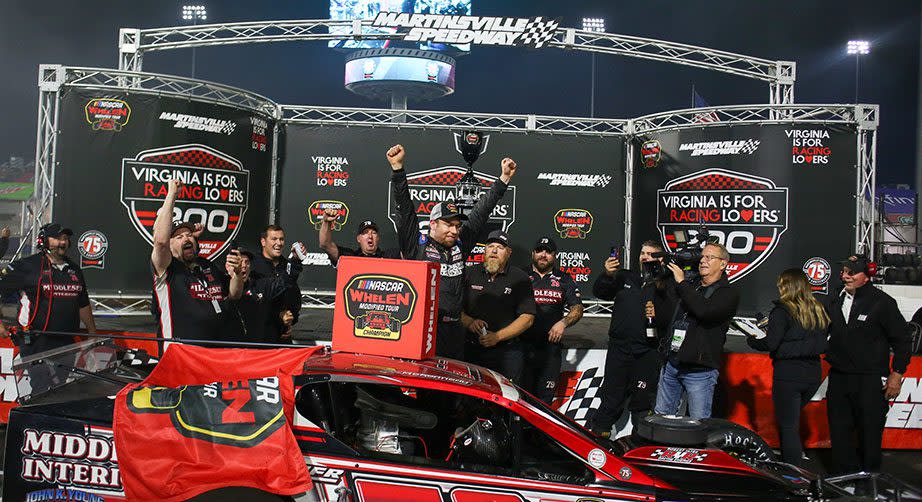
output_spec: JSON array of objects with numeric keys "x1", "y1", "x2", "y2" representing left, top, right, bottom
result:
[{"x1": 387, "y1": 145, "x2": 516, "y2": 360}]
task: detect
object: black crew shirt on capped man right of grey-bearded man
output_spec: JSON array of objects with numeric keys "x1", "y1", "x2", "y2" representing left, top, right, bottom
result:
[{"x1": 522, "y1": 270, "x2": 583, "y2": 342}]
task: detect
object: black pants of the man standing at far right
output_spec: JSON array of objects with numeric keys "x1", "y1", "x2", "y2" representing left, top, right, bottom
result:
[{"x1": 826, "y1": 370, "x2": 887, "y2": 474}]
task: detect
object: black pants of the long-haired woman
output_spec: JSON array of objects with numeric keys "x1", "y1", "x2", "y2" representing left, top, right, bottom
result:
[{"x1": 772, "y1": 379, "x2": 820, "y2": 466}]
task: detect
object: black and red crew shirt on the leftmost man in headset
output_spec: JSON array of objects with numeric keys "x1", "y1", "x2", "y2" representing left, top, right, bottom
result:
[{"x1": 0, "y1": 253, "x2": 90, "y2": 355}]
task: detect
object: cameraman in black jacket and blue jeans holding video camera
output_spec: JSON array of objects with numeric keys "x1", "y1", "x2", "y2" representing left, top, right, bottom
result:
[{"x1": 656, "y1": 243, "x2": 739, "y2": 418}]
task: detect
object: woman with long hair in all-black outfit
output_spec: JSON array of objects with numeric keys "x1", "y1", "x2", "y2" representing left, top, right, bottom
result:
[{"x1": 746, "y1": 268, "x2": 829, "y2": 466}]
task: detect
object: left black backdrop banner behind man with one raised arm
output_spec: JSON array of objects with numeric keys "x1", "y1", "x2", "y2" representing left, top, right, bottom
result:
[{"x1": 53, "y1": 89, "x2": 275, "y2": 293}]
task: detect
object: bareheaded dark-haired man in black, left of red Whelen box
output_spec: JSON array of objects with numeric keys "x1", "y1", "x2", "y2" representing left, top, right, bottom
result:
[{"x1": 250, "y1": 225, "x2": 307, "y2": 343}]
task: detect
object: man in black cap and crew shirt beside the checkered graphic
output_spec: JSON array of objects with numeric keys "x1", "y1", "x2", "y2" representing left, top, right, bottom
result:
[{"x1": 521, "y1": 237, "x2": 583, "y2": 404}]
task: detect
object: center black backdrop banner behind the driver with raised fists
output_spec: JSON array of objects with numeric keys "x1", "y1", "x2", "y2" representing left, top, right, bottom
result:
[{"x1": 279, "y1": 124, "x2": 624, "y2": 296}]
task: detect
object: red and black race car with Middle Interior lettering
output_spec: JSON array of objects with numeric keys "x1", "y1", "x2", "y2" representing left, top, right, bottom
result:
[{"x1": 3, "y1": 342, "x2": 880, "y2": 502}]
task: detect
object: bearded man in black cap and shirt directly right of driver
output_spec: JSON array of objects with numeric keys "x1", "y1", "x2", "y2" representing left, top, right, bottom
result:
[{"x1": 461, "y1": 230, "x2": 536, "y2": 382}]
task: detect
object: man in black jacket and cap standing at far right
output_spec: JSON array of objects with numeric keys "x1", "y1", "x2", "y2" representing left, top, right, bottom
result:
[{"x1": 826, "y1": 256, "x2": 910, "y2": 473}]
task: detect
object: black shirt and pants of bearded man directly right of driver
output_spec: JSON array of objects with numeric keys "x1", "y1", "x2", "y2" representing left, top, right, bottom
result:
[{"x1": 464, "y1": 264, "x2": 536, "y2": 382}]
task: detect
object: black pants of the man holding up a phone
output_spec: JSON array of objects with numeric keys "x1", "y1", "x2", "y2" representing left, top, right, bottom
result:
[{"x1": 589, "y1": 341, "x2": 662, "y2": 431}]
